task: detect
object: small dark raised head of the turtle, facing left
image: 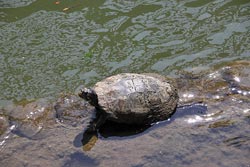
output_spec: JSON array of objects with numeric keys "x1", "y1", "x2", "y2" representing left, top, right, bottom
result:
[{"x1": 78, "y1": 88, "x2": 98, "y2": 107}]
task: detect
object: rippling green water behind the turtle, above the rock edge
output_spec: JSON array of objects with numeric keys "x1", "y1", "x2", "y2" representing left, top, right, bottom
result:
[{"x1": 0, "y1": 0, "x2": 250, "y2": 105}]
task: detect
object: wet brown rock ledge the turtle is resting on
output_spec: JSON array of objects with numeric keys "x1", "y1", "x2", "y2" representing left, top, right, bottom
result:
[{"x1": 0, "y1": 61, "x2": 250, "y2": 167}]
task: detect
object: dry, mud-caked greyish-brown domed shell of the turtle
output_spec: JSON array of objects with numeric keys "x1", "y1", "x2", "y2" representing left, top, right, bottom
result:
[{"x1": 93, "y1": 73, "x2": 179, "y2": 124}]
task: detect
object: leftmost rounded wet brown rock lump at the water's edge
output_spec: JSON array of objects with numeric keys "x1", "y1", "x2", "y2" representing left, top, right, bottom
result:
[{"x1": 1, "y1": 99, "x2": 54, "y2": 139}]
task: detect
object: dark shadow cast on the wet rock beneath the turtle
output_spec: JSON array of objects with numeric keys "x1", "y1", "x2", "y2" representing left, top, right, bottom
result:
[{"x1": 77, "y1": 103, "x2": 207, "y2": 151}]
